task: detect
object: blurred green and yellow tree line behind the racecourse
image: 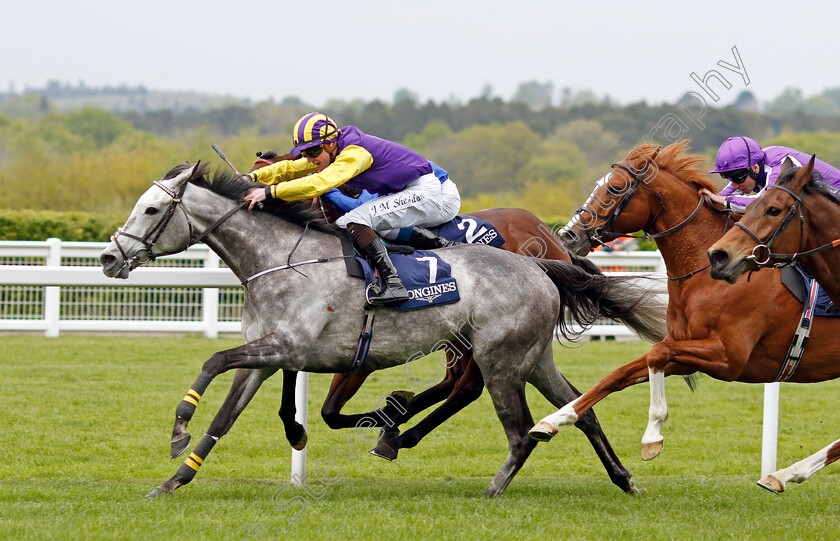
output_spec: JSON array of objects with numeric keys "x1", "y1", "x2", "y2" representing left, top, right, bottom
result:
[{"x1": 0, "y1": 96, "x2": 840, "y2": 228}]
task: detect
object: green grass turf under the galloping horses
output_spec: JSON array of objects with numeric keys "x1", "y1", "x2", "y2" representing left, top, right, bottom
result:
[{"x1": 0, "y1": 335, "x2": 840, "y2": 540}]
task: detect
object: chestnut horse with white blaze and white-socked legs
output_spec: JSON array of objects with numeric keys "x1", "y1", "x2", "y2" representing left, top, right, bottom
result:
[{"x1": 530, "y1": 141, "x2": 840, "y2": 492}]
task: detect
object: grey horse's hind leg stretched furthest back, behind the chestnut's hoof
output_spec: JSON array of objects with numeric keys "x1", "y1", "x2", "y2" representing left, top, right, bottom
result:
[{"x1": 528, "y1": 347, "x2": 639, "y2": 494}]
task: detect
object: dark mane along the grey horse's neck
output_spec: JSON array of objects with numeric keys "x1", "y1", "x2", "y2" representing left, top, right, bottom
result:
[{"x1": 163, "y1": 162, "x2": 342, "y2": 235}]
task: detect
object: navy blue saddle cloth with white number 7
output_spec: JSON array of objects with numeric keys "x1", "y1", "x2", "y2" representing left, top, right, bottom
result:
[{"x1": 356, "y1": 250, "x2": 461, "y2": 312}]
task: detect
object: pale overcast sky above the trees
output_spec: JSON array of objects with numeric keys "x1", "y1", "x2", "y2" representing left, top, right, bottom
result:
[{"x1": 0, "y1": 0, "x2": 840, "y2": 105}]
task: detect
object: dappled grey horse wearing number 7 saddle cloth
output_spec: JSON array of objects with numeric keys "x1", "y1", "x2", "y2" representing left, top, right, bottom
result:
[{"x1": 100, "y1": 164, "x2": 664, "y2": 497}]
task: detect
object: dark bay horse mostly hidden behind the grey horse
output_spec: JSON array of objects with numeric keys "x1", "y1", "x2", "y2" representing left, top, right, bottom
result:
[{"x1": 249, "y1": 151, "x2": 665, "y2": 472}]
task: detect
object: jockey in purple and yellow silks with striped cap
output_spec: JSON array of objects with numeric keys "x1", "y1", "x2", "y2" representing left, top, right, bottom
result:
[{"x1": 245, "y1": 113, "x2": 461, "y2": 304}]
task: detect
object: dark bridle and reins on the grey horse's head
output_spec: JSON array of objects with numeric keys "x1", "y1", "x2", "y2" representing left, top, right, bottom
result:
[{"x1": 111, "y1": 180, "x2": 248, "y2": 271}]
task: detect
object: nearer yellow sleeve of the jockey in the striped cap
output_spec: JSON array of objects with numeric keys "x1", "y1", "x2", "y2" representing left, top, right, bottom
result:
[{"x1": 266, "y1": 145, "x2": 373, "y2": 201}]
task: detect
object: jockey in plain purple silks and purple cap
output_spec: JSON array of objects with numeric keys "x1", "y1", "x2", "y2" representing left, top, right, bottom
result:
[{"x1": 701, "y1": 137, "x2": 840, "y2": 214}]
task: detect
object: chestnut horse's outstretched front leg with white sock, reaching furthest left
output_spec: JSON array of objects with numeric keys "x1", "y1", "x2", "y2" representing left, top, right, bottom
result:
[{"x1": 529, "y1": 355, "x2": 648, "y2": 441}]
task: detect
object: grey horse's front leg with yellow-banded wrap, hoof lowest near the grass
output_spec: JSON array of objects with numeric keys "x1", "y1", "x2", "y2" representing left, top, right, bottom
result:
[{"x1": 148, "y1": 368, "x2": 277, "y2": 498}]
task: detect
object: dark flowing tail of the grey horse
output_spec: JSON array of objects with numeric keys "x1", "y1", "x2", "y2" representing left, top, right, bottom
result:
[{"x1": 538, "y1": 256, "x2": 668, "y2": 342}]
